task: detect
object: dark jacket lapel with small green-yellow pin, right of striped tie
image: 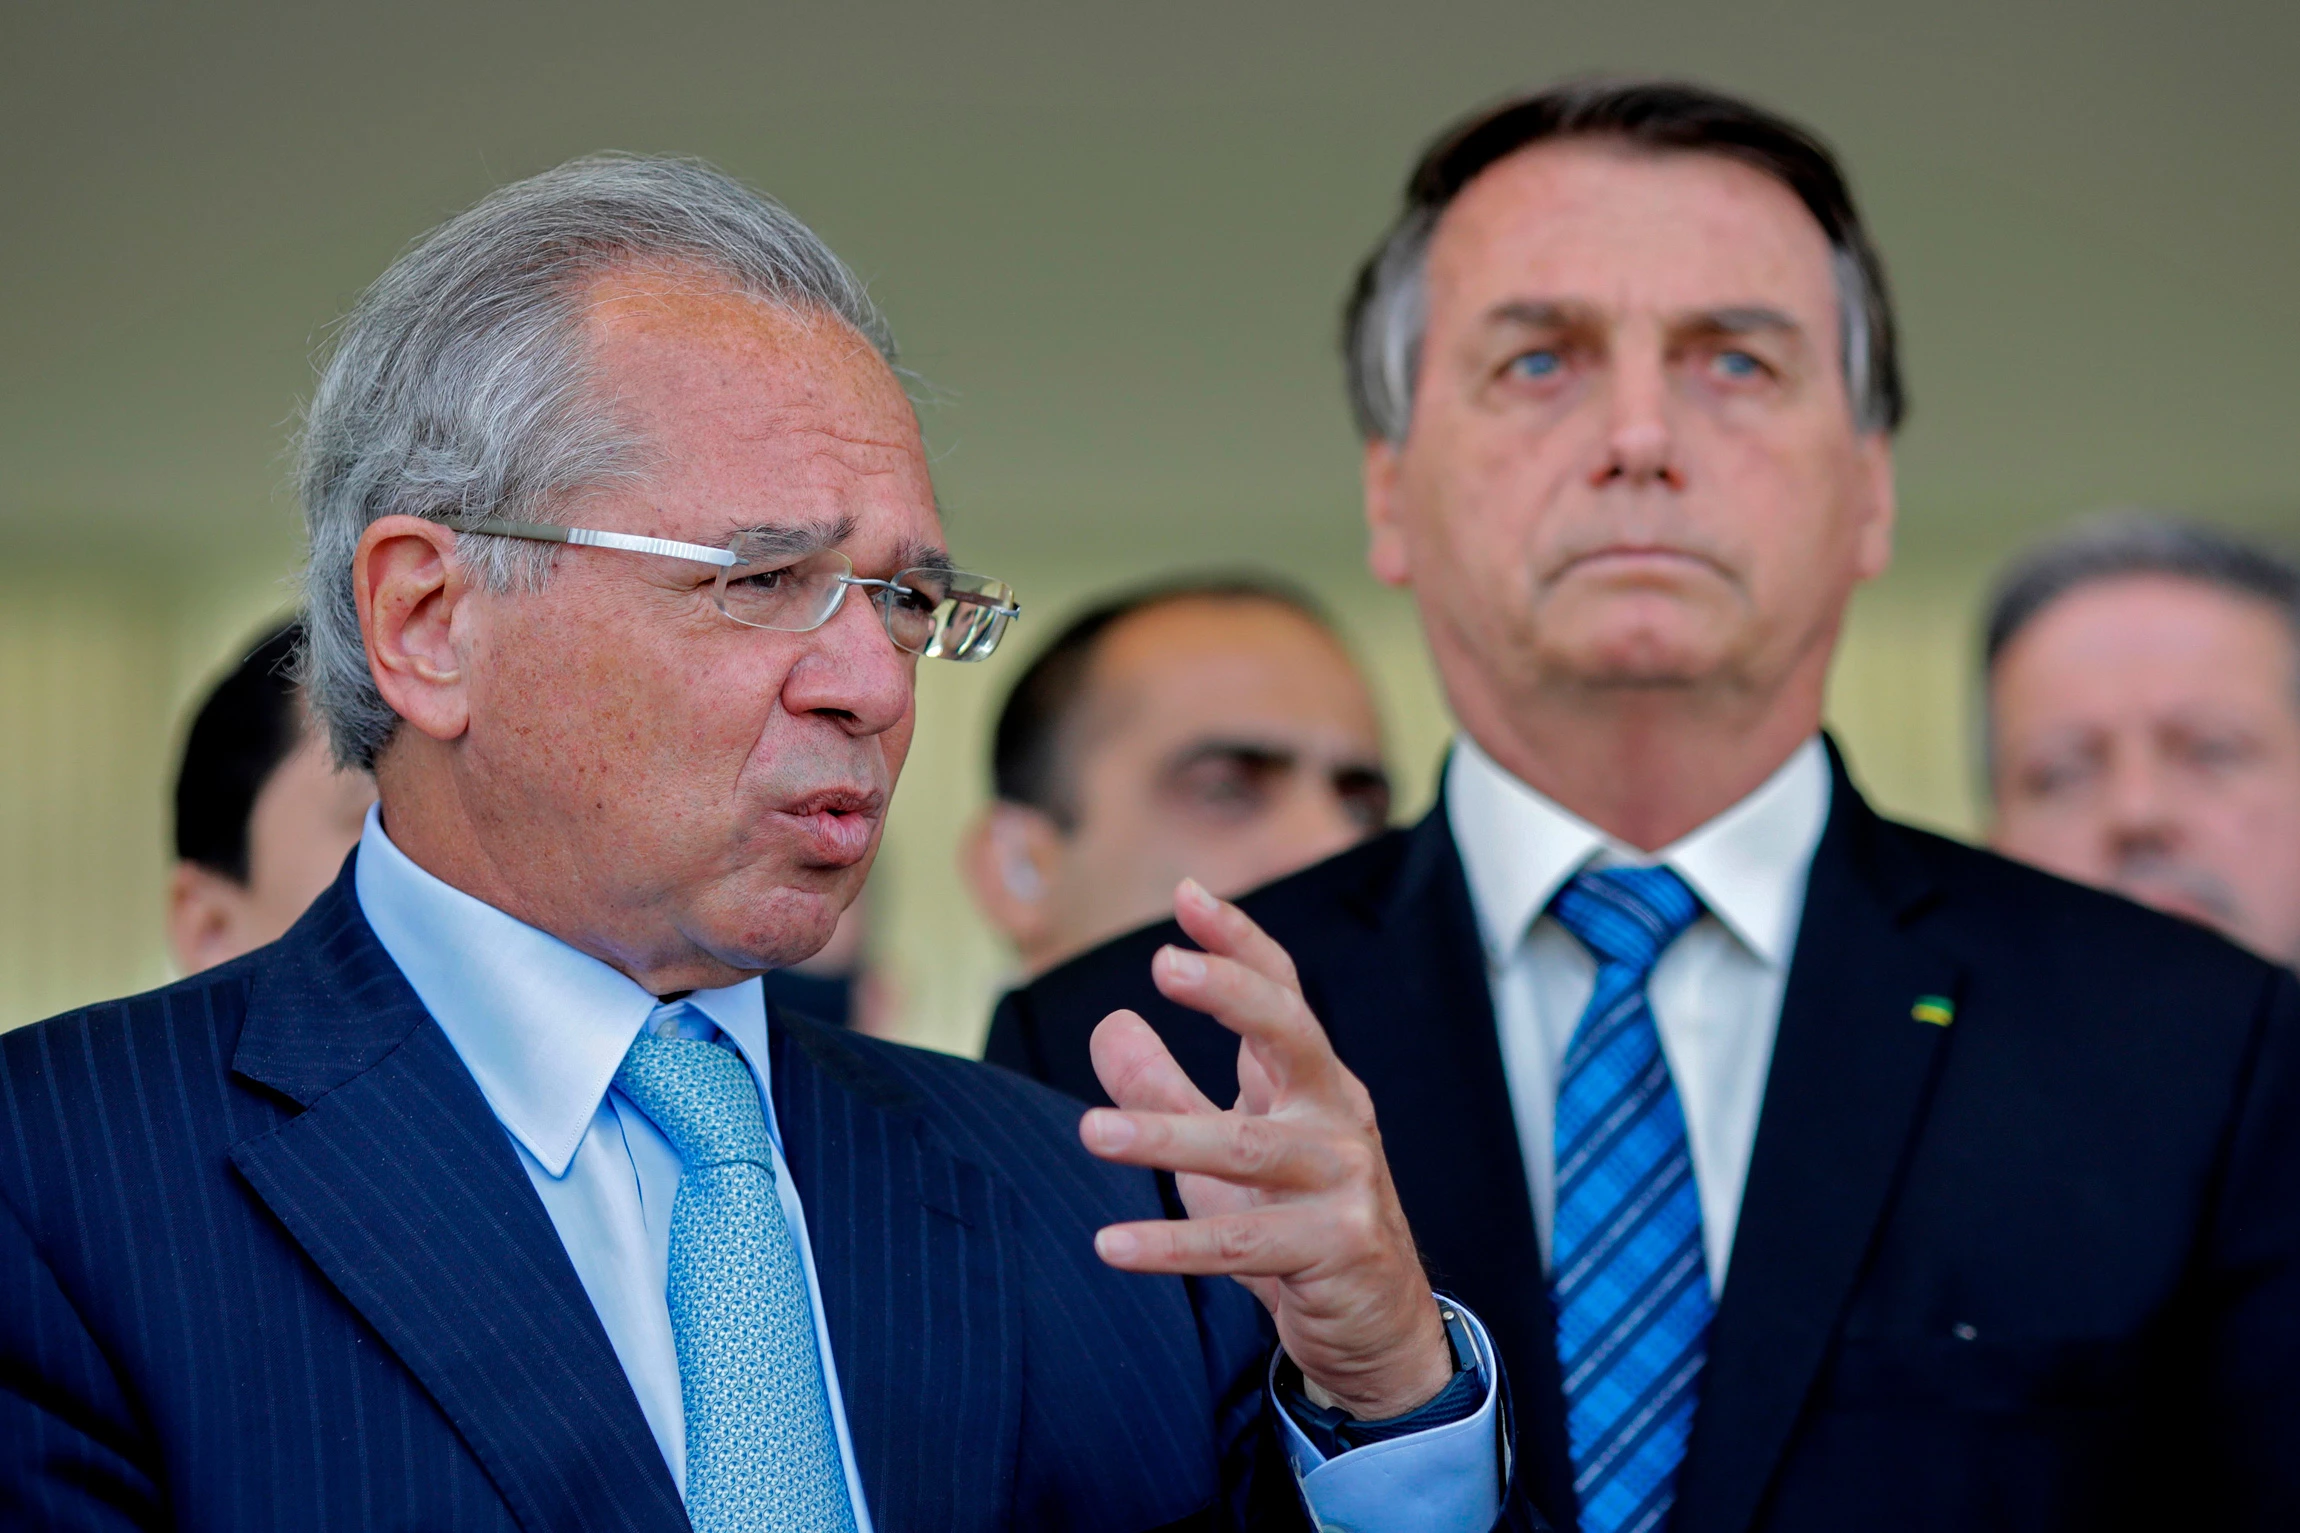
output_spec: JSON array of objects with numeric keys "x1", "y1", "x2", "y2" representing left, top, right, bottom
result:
[{"x1": 1670, "y1": 752, "x2": 1957, "y2": 1533}]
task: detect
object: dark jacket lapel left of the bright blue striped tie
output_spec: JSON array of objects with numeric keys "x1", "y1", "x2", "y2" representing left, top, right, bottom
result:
[{"x1": 1309, "y1": 798, "x2": 1573, "y2": 1505}]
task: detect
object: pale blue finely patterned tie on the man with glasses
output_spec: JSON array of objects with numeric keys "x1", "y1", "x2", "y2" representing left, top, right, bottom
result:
[{"x1": 614, "y1": 1032, "x2": 856, "y2": 1533}]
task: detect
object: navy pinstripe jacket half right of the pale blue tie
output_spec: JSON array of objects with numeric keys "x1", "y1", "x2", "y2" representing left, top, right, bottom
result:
[{"x1": 771, "y1": 1018, "x2": 1302, "y2": 1531}]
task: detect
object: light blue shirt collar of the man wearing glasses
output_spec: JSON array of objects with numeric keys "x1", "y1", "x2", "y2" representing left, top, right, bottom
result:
[{"x1": 352, "y1": 807, "x2": 768, "y2": 1177}]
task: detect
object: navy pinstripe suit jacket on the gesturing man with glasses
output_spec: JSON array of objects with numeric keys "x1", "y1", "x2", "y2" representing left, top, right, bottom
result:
[{"x1": 0, "y1": 873, "x2": 1530, "y2": 1533}]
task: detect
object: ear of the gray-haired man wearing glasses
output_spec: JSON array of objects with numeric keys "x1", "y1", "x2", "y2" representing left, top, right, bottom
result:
[{"x1": 352, "y1": 517, "x2": 472, "y2": 740}]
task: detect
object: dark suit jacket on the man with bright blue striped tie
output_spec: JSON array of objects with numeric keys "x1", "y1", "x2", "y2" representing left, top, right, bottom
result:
[{"x1": 989, "y1": 756, "x2": 2300, "y2": 1533}]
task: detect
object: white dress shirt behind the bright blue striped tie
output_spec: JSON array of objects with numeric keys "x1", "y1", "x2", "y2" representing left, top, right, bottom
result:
[{"x1": 1444, "y1": 735, "x2": 1829, "y2": 1294}]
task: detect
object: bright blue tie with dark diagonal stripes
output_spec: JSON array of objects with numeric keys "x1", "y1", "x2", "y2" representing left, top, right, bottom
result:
[{"x1": 1550, "y1": 869, "x2": 1714, "y2": 1533}]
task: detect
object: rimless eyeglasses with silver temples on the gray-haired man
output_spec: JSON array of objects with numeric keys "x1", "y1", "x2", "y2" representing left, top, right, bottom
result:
[{"x1": 462, "y1": 517, "x2": 1021, "y2": 660}]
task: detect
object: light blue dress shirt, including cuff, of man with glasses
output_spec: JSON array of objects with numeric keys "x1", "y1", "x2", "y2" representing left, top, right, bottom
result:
[{"x1": 354, "y1": 809, "x2": 1502, "y2": 1533}]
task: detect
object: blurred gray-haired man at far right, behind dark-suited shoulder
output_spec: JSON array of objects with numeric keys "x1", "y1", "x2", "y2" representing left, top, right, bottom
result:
[{"x1": 1987, "y1": 515, "x2": 2300, "y2": 965}]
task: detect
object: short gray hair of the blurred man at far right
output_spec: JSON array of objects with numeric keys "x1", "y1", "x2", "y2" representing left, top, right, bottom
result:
[{"x1": 1978, "y1": 510, "x2": 2300, "y2": 788}]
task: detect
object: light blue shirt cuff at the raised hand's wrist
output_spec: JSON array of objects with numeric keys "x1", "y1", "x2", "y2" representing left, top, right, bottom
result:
[{"x1": 1267, "y1": 1299, "x2": 1509, "y2": 1533}]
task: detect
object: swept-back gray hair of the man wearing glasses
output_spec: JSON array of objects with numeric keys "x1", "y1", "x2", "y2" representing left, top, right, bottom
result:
[{"x1": 297, "y1": 154, "x2": 895, "y2": 770}]
